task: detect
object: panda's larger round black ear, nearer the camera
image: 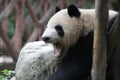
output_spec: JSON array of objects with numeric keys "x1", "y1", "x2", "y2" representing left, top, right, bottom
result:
[{"x1": 68, "y1": 5, "x2": 81, "y2": 17}]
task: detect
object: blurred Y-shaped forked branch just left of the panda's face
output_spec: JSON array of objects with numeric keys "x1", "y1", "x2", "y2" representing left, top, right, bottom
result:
[{"x1": 26, "y1": 2, "x2": 55, "y2": 42}]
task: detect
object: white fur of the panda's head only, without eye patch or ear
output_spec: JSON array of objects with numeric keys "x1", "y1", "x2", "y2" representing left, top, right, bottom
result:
[{"x1": 42, "y1": 10, "x2": 82, "y2": 47}]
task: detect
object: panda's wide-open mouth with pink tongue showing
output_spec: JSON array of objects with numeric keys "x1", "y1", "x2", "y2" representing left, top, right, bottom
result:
[{"x1": 54, "y1": 42, "x2": 63, "y2": 58}]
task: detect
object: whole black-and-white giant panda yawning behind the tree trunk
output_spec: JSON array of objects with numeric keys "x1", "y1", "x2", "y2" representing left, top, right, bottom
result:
[{"x1": 42, "y1": 5, "x2": 118, "y2": 80}]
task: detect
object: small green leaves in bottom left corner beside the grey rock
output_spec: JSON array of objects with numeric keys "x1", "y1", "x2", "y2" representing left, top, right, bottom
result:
[{"x1": 0, "y1": 69, "x2": 15, "y2": 80}]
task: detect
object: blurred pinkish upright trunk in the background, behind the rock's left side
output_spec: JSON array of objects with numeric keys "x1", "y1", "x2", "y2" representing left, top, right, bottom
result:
[{"x1": 14, "y1": 0, "x2": 25, "y2": 53}]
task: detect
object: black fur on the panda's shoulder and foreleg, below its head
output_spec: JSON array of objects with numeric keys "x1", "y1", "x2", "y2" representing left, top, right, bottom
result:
[{"x1": 49, "y1": 31, "x2": 93, "y2": 80}]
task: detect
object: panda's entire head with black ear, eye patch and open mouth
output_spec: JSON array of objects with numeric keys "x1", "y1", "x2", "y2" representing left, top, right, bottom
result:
[{"x1": 42, "y1": 5, "x2": 82, "y2": 58}]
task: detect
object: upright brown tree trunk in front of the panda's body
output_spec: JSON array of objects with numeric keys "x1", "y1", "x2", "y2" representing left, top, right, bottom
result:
[{"x1": 91, "y1": 0, "x2": 108, "y2": 80}]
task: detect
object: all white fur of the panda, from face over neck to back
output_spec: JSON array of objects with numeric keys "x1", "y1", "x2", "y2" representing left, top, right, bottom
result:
[{"x1": 42, "y1": 9, "x2": 117, "y2": 47}]
